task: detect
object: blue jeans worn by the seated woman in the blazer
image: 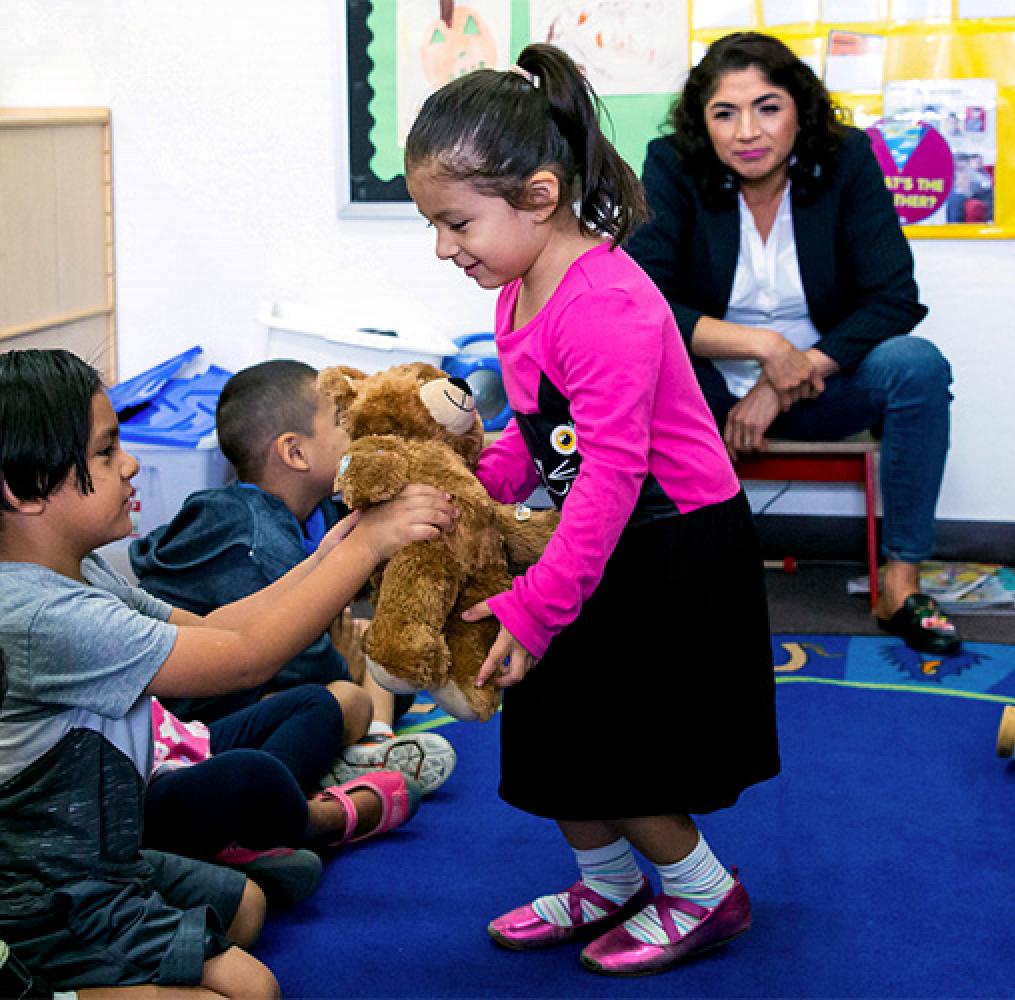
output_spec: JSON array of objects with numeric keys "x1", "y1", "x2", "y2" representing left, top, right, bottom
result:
[{"x1": 694, "y1": 334, "x2": 952, "y2": 562}]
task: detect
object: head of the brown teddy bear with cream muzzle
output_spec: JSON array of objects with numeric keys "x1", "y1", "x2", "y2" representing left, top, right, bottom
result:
[{"x1": 322, "y1": 361, "x2": 483, "y2": 466}]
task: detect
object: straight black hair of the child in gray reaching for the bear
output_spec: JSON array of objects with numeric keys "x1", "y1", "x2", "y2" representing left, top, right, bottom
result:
[{"x1": 0, "y1": 350, "x2": 103, "y2": 511}]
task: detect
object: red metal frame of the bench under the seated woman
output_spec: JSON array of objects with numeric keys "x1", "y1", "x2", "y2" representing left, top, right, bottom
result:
[{"x1": 737, "y1": 448, "x2": 878, "y2": 611}]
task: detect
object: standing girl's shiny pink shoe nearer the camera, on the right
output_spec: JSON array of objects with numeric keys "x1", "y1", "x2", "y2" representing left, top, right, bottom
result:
[{"x1": 582, "y1": 872, "x2": 751, "y2": 976}]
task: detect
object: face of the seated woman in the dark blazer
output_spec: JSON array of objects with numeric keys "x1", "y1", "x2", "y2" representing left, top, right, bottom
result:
[{"x1": 704, "y1": 66, "x2": 800, "y2": 186}]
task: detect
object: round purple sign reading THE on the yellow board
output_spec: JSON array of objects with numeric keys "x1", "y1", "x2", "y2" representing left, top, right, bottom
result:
[{"x1": 867, "y1": 119, "x2": 955, "y2": 225}]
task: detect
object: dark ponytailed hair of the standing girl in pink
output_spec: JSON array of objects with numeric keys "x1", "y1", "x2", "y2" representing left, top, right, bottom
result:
[{"x1": 405, "y1": 44, "x2": 646, "y2": 246}]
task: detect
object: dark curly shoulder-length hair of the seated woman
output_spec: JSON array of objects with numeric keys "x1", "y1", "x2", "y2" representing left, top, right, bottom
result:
[{"x1": 667, "y1": 31, "x2": 844, "y2": 206}]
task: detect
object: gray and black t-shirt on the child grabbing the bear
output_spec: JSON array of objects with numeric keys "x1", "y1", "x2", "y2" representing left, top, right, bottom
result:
[{"x1": 0, "y1": 555, "x2": 177, "y2": 920}]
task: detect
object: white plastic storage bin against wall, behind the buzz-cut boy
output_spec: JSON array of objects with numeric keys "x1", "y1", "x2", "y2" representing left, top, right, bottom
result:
[{"x1": 258, "y1": 303, "x2": 458, "y2": 375}]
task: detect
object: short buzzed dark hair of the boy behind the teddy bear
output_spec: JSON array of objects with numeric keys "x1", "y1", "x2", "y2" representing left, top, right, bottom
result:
[{"x1": 215, "y1": 360, "x2": 318, "y2": 482}]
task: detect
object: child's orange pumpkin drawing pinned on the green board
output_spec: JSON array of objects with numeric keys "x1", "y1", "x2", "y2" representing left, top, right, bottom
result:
[{"x1": 395, "y1": 0, "x2": 511, "y2": 146}]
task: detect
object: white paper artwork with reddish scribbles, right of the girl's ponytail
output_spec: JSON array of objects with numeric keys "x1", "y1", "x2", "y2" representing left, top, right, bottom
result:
[{"x1": 529, "y1": 0, "x2": 687, "y2": 95}]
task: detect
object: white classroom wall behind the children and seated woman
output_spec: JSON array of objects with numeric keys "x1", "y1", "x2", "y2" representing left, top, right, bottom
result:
[{"x1": 0, "y1": 0, "x2": 1015, "y2": 521}]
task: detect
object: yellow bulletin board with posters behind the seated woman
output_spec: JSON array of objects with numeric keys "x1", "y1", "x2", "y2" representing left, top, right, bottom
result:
[{"x1": 688, "y1": 0, "x2": 1015, "y2": 240}]
